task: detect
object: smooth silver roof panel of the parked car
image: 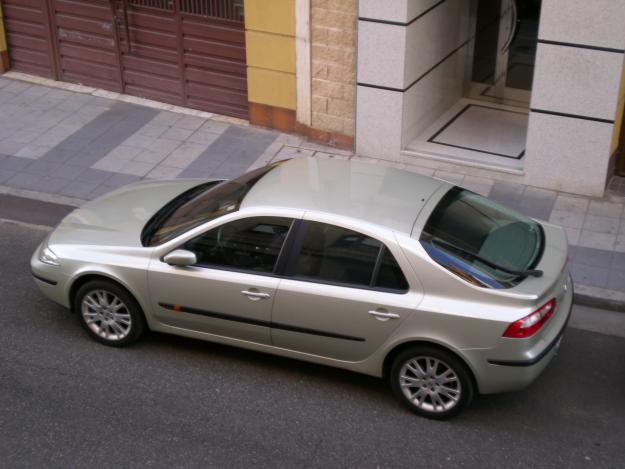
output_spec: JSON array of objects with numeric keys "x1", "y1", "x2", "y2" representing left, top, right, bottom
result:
[{"x1": 241, "y1": 158, "x2": 452, "y2": 234}]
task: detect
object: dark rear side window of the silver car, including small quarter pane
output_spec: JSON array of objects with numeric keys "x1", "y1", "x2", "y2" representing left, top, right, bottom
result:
[{"x1": 293, "y1": 222, "x2": 408, "y2": 291}]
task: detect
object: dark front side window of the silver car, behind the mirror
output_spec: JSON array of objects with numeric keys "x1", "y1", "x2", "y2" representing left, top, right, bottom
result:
[{"x1": 184, "y1": 217, "x2": 292, "y2": 273}]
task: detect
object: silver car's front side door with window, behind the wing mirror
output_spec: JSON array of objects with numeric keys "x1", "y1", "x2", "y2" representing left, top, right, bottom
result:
[{"x1": 148, "y1": 217, "x2": 292, "y2": 344}]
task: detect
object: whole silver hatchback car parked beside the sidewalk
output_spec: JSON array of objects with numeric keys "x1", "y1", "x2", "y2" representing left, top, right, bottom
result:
[{"x1": 31, "y1": 159, "x2": 573, "y2": 418}]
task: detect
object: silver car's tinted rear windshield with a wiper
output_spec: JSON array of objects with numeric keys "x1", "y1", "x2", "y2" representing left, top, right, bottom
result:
[{"x1": 420, "y1": 187, "x2": 543, "y2": 288}]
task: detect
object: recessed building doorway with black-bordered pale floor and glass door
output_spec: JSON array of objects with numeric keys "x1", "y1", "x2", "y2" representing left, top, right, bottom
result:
[{"x1": 407, "y1": 0, "x2": 541, "y2": 170}]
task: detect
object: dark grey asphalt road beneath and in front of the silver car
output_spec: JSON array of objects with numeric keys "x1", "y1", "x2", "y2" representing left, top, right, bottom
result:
[{"x1": 0, "y1": 198, "x2": 625, "y2": 468}]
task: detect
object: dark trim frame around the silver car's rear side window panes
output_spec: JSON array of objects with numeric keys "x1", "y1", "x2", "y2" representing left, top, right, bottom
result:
[{"x1": 282, "y1": 220, "x2": 410, "y2": 295}]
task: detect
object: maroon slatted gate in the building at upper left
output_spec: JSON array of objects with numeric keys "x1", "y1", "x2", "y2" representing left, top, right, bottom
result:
[{"x1": 2, "y1": 0, "x2": 247, "y2": 118}]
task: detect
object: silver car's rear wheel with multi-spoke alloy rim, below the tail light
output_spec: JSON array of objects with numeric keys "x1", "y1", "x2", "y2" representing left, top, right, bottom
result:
[{"x1": 389, "y1": 346, "x2": 475, "y2": 420}]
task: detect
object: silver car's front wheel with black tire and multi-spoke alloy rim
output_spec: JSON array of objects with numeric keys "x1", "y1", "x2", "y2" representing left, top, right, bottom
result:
[{"x1": 73, "y1": 280, "x2": 147, "y2": 347}]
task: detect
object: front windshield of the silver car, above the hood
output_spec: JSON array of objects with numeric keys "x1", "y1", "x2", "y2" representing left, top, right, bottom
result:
[{"x1": 141, "y1": 164, "x2": 276, "y2": 246}]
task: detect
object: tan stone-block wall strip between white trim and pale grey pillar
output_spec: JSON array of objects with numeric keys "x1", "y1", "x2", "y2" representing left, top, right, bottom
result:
[{"x1": 311, "y1": 0, "x2": 358, "y2": 137}]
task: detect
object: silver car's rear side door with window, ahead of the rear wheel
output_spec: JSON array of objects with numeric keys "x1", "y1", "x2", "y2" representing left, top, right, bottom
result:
[{"x1": 272, "y1": 222, "x2": 421, "y2": 361}]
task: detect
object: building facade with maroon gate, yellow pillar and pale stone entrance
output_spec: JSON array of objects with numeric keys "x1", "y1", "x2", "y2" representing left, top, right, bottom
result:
[{"x1": 0, "y1": 0, "x2": 625, "y2": 196}]
